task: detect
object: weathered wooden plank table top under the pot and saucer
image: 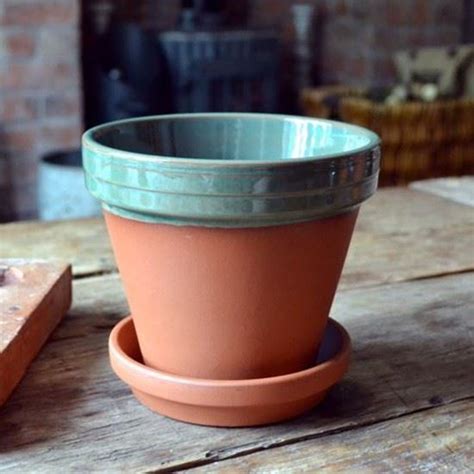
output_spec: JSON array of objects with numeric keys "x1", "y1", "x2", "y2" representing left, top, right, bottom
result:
[{"x1": 0, "y1": 179, "x2": 474, "y2": 473}]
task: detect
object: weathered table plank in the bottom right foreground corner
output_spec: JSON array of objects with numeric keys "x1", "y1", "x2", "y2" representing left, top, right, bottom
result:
[{"x1": 191, "y1": 400, "x2": 474, "y2": 474}]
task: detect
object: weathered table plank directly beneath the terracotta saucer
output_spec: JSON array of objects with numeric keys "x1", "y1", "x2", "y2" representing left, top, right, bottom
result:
[{"x1": 0, "y1": 273, "x2": 474, "y2": 472}]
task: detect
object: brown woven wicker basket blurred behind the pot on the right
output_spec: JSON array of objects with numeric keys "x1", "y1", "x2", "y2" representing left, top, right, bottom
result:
[{"x1": 303, "y1": 87, "x2": 474, "y2": 186}]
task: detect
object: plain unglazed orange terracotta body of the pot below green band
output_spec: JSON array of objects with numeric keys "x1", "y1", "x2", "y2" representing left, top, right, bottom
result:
[{"x1": 105, "y1": 209, "x2": 358, "y2": 379}]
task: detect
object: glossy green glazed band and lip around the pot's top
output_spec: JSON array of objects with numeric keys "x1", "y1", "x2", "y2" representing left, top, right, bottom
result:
[{"x1": 82, "y1": 113, "x2": 380, "y2": 227}]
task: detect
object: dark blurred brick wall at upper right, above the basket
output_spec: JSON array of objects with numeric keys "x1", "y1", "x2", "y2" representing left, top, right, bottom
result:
[{"x1": 250, "y1": 0, "x2": 464, "y2": 85}]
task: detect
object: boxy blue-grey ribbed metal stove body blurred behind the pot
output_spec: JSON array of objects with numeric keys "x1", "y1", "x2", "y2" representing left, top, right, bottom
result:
[{"x1": 159, "y1": 30, "x2": 279, "y2": 112}]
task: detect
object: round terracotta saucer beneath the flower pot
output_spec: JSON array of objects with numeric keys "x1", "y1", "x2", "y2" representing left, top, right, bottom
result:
[{"x1": 109, "y1": 316, "x2": 351, "y2": 426}]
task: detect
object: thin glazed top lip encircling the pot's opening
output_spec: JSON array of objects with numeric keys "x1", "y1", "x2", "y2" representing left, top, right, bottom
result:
[{"x1": 82, "y1": 112, "x2": 381, "y2": 169}]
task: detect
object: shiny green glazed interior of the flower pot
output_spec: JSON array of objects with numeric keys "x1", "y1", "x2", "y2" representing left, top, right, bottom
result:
[{"x1": 92, "y1": 114, "x2": 378, "y2": 162}]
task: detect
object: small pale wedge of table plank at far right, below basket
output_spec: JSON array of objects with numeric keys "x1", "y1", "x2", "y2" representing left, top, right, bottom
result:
[{"x1": 409, "y1": 176, "x2": 474, "y2": 206}]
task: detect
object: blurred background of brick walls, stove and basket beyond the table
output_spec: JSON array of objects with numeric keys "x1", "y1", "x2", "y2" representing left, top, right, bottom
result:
[{"x1": 0, "y1": 0, "x2": 474, "y2": 222}]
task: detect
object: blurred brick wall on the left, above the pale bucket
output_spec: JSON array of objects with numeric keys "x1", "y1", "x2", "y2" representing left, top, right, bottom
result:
[{"x1": 0, "y1": 0, "x2": 82, "y2": 221}]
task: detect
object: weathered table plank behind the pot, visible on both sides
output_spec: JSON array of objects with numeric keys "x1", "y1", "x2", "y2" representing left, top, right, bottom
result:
[{"x1": 0, "y1": 188, "x2": 474, "y2": 288}]
